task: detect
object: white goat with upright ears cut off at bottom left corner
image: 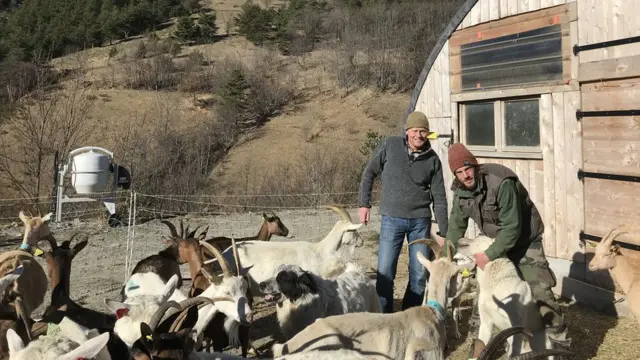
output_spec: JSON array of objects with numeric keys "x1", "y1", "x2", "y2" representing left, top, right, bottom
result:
[{"x1": 7, "y1": 317, "x2": 111, "y2": 360}]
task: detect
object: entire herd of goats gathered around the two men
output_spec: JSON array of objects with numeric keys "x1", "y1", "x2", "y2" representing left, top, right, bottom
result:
[{"x1": 0, "y1": 205, "x2": 640, "y2": 360}]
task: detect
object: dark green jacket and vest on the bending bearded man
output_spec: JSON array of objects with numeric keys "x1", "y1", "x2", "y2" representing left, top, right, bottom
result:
[{"x1": 444, "y1": 164, "x2": 544, "y2": 261}]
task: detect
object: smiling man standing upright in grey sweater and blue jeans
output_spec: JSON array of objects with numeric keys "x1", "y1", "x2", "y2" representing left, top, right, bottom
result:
[{"x1": 358, "y1": 111, "x2": 448, "y2": 313}]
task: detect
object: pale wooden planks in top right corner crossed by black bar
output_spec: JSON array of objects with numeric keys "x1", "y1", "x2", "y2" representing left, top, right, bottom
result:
[{"x1": 577, "y1": 0, "x2": 640, "y2": 63}]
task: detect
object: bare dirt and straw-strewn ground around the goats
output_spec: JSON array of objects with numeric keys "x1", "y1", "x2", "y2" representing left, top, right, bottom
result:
[{"x1": 0, "y1": 208, "x2": 640, "y2": 360}]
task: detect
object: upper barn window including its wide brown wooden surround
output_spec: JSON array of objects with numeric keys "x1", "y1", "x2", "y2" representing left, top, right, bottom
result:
[{"x1": 448, "y1": 2, "x2": 578, "y2": 95}]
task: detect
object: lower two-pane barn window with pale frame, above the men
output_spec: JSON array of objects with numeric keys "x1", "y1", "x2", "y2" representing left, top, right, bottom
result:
[{"x1": 460, "y1": 97, "x2": 541, "y2": 156}]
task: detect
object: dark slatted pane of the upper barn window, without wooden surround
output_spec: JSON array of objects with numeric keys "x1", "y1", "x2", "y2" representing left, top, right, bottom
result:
[{"x1": 460, "y1": 25, "x2": 562, "y2": 91}]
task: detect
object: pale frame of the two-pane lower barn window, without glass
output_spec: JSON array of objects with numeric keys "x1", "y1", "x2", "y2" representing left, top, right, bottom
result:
[{"x1": 458, "y1": 95, "x2": 542, "y2": 159}]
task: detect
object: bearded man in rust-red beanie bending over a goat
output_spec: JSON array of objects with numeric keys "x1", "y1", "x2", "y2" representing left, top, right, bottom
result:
[{"x1": 444, "y1": 143, "x2": 571, "y2": 358}]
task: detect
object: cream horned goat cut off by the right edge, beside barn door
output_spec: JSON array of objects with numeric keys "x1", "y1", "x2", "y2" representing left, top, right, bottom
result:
[{"x1": 589, "y1": 226, "x2": 640, "y2": 323}]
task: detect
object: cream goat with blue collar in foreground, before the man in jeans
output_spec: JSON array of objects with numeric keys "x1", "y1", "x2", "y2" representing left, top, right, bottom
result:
[{"x1": 272, "y1": 239, "x2": 465, "y2": 359}]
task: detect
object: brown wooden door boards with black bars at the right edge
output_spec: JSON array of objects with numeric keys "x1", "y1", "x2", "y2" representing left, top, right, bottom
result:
[{"x1": 580, "y1": 78, "x2": 640, "y2": 248}]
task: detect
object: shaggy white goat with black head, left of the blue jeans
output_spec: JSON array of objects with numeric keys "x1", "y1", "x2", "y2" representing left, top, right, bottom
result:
[{"x1": 259, "y1": 262, "x2": 382, "y2": 340}]
